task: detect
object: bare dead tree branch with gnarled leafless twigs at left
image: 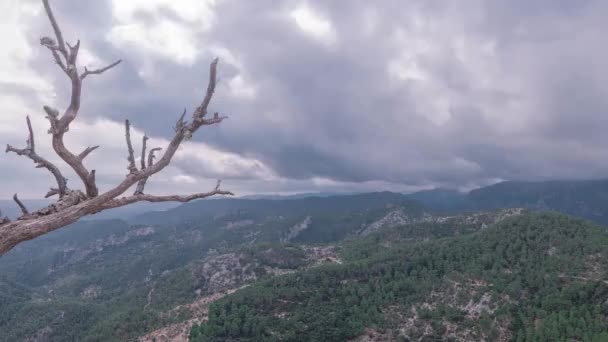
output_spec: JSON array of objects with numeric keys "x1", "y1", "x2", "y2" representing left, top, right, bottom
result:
[{"x1": 0, "y1": 0, "x2": 232, "y2": 256}]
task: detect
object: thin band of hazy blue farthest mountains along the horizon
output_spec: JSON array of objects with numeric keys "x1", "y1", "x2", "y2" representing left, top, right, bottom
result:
[{"x1": 133, "y1": 180, "x2": 608, "y2": 224}]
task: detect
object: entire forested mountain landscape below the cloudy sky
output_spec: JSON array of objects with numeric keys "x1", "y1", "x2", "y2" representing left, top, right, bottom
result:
[{"x1": 0, "y1": 180, "x2": 608, "y2": 341}]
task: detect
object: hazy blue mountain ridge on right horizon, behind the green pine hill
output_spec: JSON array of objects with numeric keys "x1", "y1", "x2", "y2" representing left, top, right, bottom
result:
[{"x1": 407, "y1": 179, "x2": 608, "y2": 224}]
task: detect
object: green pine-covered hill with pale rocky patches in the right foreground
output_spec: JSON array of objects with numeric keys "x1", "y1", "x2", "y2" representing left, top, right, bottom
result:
[{"x1": 191, "y1": 213, "x2": 608, "y2": 341}]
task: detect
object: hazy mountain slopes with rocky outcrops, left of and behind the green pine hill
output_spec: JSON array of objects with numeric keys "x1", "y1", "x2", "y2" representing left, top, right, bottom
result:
[{"x1": 0, "y1": 193, "x2": 430, "y2": 341}]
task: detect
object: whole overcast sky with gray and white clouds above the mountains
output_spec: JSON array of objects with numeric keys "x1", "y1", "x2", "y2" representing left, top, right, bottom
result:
[{"x1": 0, "y1": 0, "x2": 608, "y2": 198}]
